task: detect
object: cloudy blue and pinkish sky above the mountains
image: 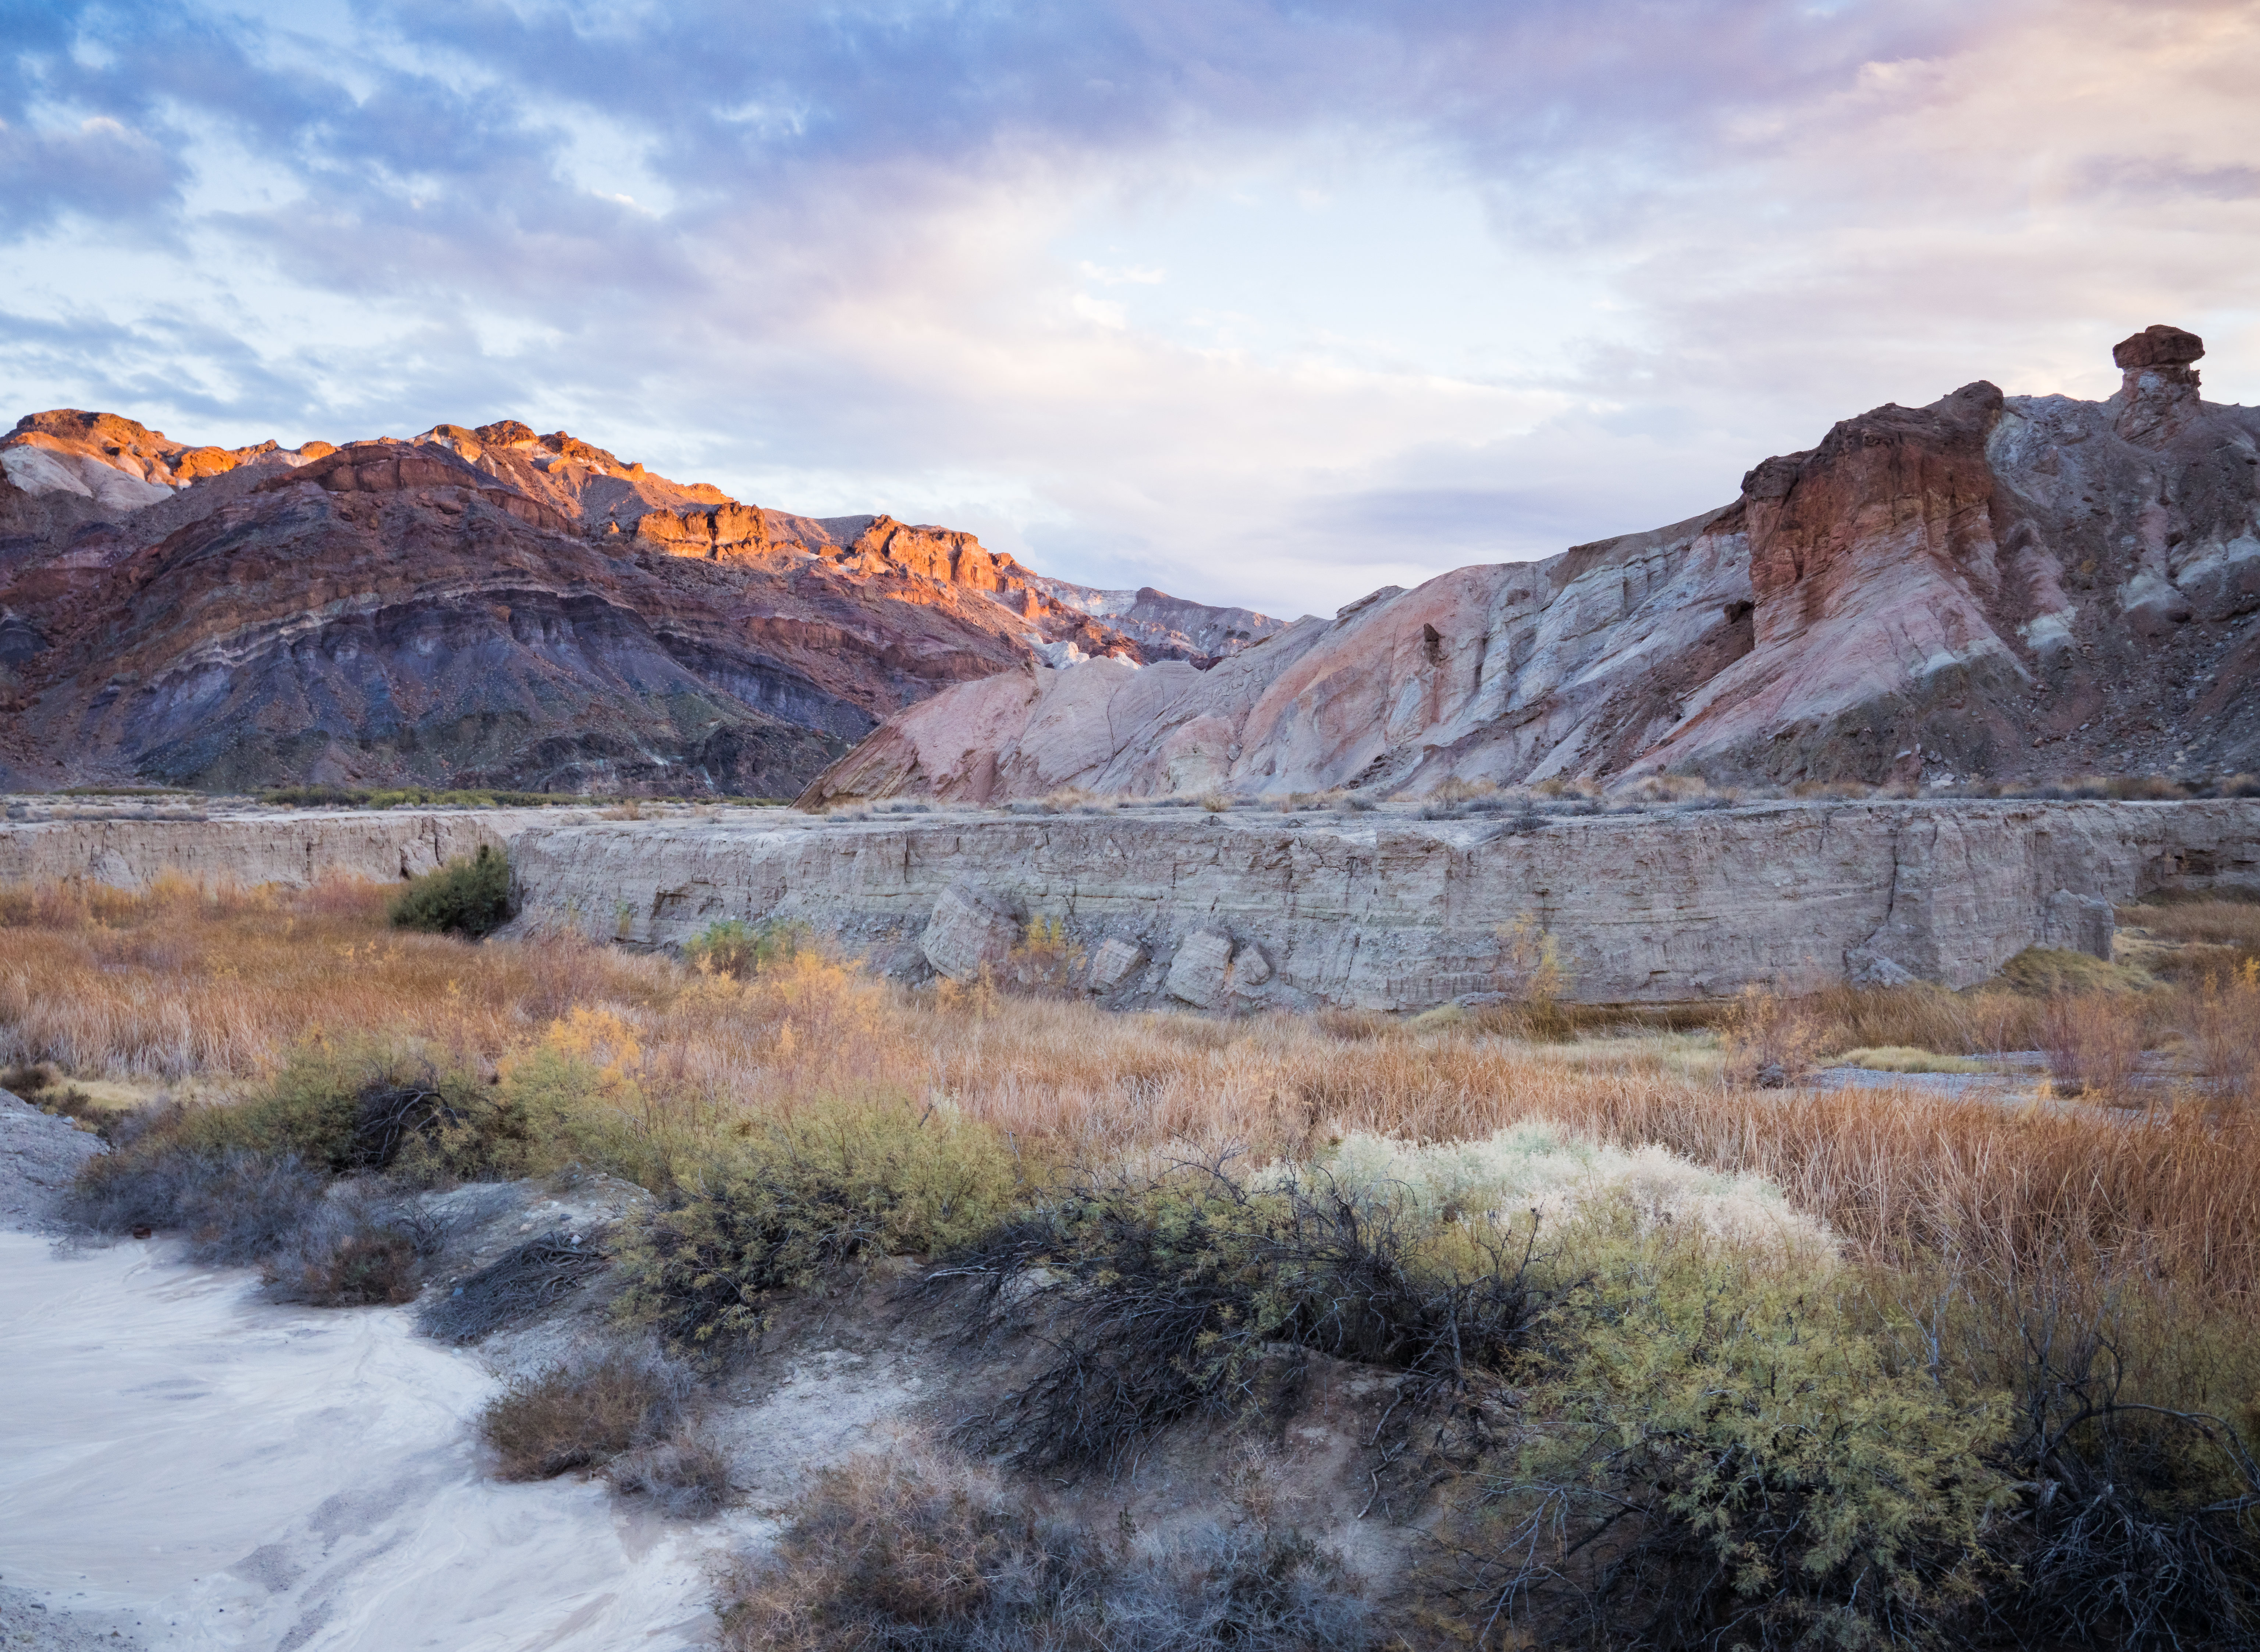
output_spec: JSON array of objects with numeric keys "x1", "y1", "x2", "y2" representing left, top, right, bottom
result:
[{"x1": 0, "y1": 0, "x2": 2260, "y2": 615}]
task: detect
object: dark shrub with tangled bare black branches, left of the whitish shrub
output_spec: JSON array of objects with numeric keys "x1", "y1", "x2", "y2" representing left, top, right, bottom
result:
[{"x1": 922, "y1": 1162, "x2": 1530, "y2": 1471}]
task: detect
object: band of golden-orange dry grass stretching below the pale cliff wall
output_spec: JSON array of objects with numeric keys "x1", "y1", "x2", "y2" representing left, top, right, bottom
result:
[{"x1": 13, "y1": 881, "x2": 2260, "y2": 1304}]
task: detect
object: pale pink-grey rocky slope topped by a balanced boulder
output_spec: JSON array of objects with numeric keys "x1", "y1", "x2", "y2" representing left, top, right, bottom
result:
[{"x1": 809, "y1": 326, "x2": 2260, "y2": 802}]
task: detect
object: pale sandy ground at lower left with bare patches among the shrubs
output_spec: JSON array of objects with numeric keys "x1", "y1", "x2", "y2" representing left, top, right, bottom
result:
[{"x1": 0, "y1": 1112, "x2": 1403, "y2": 1652}]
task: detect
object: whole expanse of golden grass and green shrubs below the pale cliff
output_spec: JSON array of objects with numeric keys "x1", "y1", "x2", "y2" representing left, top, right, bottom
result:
[{"x1": 0, "y1": 881, "x2": 2260, "y2": 1648}]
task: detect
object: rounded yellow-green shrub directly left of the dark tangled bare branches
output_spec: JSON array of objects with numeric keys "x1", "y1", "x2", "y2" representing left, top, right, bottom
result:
[{"x1": 619, "y1": 1101, "x2": 1019, "y2": 1354}]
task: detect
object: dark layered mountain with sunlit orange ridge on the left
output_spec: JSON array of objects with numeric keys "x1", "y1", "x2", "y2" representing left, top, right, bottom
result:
[{"x1": 0, "y1": 409, "x2": 1277, "y2": 796}]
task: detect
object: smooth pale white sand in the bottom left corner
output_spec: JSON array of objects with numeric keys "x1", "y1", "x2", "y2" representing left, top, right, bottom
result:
[{"x1": 0, "y1": 1232, "x2": 771, "y2": 1652}]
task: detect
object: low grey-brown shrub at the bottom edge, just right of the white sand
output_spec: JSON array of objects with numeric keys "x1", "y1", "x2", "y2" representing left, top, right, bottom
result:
[{"x1": 717, "y1": 1442, "x2": 1372, "y2": 1652}]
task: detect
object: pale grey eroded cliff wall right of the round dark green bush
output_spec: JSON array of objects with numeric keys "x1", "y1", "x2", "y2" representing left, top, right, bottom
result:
[{"x1": 513, "y1": 802, "x2": 2260, "y2": 1010}]
